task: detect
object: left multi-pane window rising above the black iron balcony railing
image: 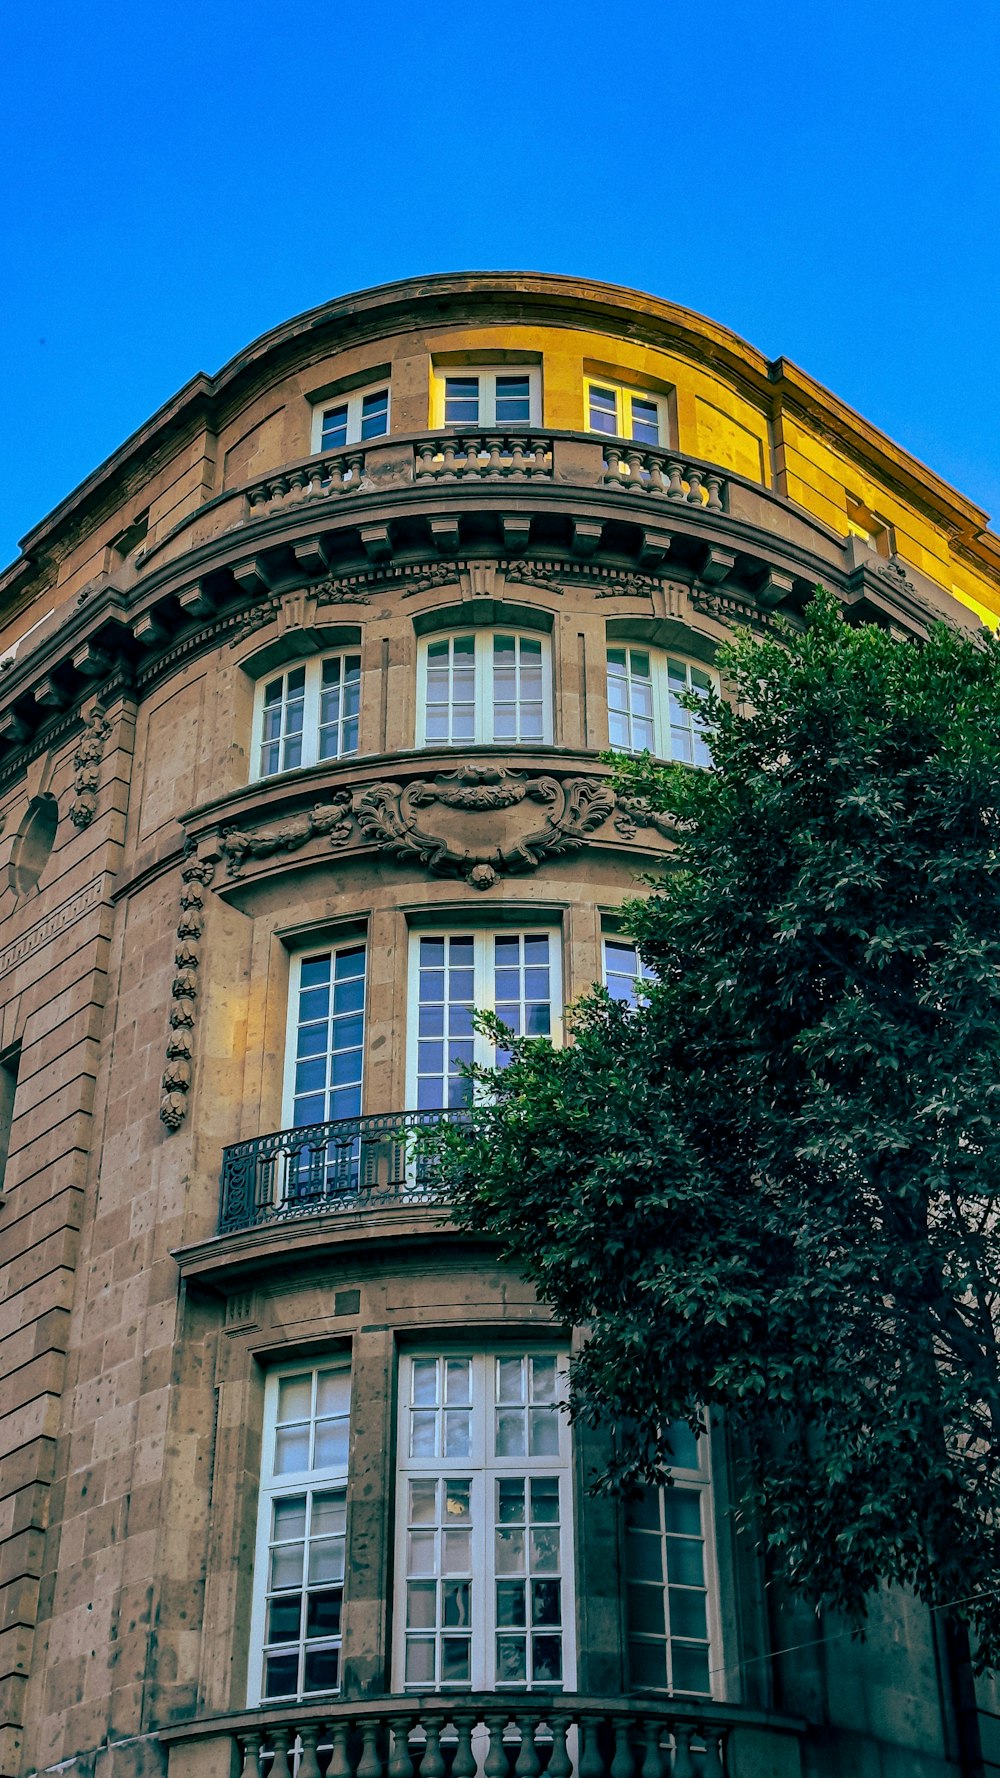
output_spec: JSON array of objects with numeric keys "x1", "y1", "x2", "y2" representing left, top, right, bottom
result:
[{"x1": 285, "y1": 944, "x2": 365, "y2": 1129}]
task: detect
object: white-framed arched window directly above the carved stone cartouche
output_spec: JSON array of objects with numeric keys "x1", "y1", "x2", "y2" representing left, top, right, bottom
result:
[{"x1": 416, "y1": 628, "x2": 552, "y2": 747}]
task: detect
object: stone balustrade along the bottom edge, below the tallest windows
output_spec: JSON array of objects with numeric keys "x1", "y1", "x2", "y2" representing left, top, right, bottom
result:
[{"x1": 164, "y1": 1693, "x2": 740, "y2": 1778}]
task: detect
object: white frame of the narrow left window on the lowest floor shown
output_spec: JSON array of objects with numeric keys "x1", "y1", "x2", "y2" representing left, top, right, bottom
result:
[{"x1": 247, "y1": 1353, "x2": 351, "y2": 1709}]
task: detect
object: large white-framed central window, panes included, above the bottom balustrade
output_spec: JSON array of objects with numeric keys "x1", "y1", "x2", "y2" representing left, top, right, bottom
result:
[{"x1": 393, "y1": 1348, "x2": 575, "y2": 1691}]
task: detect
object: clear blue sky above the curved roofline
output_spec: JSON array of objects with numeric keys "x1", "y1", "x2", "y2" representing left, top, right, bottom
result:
[{"x1": 0, "y1": 0, "x2": 1000, "y2": 562}]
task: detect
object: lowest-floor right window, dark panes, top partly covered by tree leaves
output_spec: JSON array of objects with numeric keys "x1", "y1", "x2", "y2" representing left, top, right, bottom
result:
[{"x1": 625, "y1": 1424, "x2": 722, "y2": 1696}]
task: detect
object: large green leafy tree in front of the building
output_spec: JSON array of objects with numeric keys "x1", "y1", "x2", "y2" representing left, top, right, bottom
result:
[{"x1": 435, "y1": 590, "x2": 1000, "y2": 1666}]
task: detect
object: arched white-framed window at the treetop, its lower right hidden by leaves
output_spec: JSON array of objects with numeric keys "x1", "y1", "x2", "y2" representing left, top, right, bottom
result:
[{"x1": 607, "y1": 642, "x2": 715, "y2": 766}]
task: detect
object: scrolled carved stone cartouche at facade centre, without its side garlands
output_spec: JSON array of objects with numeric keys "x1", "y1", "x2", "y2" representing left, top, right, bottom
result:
[{"x1": 356, "y1": 766, "x2": 616, "y2": 889}]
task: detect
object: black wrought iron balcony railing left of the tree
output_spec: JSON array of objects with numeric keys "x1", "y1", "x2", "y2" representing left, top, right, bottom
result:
[{"x1": 219, "y1": 1111, "x2": 466, "y2": 1234}]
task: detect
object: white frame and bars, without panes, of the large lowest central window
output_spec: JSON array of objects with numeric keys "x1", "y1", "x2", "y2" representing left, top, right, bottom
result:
[{"x1": 391, "y1": 1335, "x2": 577, "y2": 1698}]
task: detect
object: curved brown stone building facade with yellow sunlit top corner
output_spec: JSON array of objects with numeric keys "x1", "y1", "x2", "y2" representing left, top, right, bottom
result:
[{"x1": 0, "y1": 274, "x2": 1000, "y2": 1778}]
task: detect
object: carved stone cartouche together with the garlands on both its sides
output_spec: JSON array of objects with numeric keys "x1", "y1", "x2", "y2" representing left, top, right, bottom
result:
[{"x1": 210, "y1": 765, "x2": 664, "y2": 889}]
